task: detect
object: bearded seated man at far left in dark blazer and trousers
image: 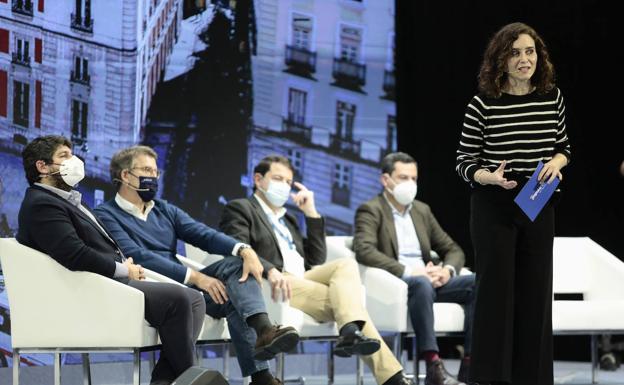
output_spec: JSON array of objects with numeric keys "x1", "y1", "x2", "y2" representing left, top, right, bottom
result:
[{"x1": 17, "y1": 136, "x2": 205, "y2": 385}]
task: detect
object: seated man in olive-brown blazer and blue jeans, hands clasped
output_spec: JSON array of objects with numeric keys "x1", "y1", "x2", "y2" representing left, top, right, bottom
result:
[{"x1": 353, "y1": 152, "x2": 474, "y2": 385}]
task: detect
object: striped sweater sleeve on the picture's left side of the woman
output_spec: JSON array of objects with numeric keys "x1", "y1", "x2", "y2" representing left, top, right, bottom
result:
[{"x1": 455, "y1": 96, "x2": 486, "y2": 182}]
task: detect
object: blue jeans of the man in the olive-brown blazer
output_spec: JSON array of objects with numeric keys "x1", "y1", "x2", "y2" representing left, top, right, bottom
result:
[{"x1": 404, "y1": 274, "x2": 475, "y2": 355}]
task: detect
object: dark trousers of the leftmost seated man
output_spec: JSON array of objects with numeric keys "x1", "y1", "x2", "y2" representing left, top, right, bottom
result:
[{"x1": 128, "y1": 281, "x2": 206, "y2": 382}]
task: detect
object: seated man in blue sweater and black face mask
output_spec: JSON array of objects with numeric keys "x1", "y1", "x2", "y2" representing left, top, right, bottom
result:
[{"x1": 95, "y1": 146, "x2": 299, "y2": 385}]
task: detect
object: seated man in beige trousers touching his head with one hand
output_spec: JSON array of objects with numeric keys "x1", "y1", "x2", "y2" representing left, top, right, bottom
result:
[{"x1": 220, "y1": 156, "x2": 409, "y2": 385}]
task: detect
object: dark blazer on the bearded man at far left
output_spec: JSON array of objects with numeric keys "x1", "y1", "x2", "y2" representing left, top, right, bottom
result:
[{"x1": 17, "y1": 186, "x2": 122, "y2": 278}]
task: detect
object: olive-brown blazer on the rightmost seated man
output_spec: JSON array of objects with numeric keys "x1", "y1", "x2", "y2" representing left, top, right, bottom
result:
[{"x1": 353, "y1": 194, "x2": 465, "y2": 277}]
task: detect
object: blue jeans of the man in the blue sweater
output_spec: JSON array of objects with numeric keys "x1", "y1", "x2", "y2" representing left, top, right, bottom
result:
[{"x1": 194, "y1": 257, "x2": 269, "y2": 377}]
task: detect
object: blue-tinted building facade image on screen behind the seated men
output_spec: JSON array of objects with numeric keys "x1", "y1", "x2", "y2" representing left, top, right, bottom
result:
[{"x1": 0, "y1": 0, "x2": 396, "y2": 365}]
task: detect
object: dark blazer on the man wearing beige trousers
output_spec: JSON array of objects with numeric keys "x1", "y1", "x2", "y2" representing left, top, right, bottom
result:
[{"x1": 219, "y1": 196, "x2": 327, "y2": 277}]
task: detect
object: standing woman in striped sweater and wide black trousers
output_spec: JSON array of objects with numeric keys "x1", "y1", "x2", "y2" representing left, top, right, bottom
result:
[{"x1": 456, "y1": 23, "x2": 570, "y2": 385}]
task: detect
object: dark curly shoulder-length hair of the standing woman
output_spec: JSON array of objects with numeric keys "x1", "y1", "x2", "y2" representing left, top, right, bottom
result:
[{"x1": 478, "y1": 23, "x2": 555, "y2": 98}]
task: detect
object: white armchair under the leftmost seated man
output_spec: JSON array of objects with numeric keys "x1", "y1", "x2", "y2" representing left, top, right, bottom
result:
[{"x1": 0, "y1": 238, "x2": 158, "y2": 385}]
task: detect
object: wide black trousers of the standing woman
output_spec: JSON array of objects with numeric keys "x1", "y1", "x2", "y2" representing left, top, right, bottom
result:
[{"x1": 470, "y1": 186, "x2": 554, "y2": 385}]
